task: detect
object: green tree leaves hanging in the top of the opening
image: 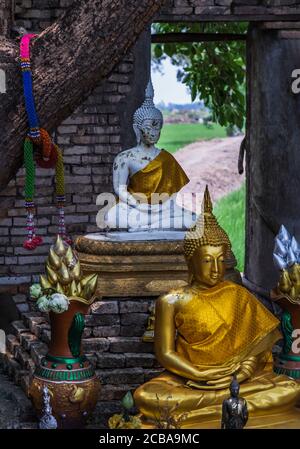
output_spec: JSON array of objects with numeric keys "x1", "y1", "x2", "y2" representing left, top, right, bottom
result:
[{"x1": 152, "y1": 23, "x2": 247, "y2": 129}]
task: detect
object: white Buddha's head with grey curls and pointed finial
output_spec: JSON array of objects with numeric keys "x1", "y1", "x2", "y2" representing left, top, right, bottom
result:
[{"x1": 133, "y1": 78, "x2": 163, "y2": 147}]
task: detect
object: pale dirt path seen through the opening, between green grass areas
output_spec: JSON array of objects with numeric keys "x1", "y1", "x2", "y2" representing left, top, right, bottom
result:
[{"x1": 174, "y1": 136, "x2": 245, "y2": 202}]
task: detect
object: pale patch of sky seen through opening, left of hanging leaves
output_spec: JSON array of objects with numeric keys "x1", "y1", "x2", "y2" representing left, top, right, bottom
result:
[{"x1": 152, "y1": 58, "x2": 191, "y2": 105}]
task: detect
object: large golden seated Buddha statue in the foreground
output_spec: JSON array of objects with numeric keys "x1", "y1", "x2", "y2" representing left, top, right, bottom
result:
[{"x1": 134, "y1": 189, "x2": 300, "y2": 428}]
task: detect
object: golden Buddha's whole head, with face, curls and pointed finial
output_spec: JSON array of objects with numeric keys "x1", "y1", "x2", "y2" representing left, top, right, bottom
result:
[{"x1": 184, "y1": 187, "x2": 234, "y2": 288}]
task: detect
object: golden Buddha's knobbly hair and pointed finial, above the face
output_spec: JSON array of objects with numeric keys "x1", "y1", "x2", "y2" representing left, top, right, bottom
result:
[{"x1": 184, "y1": 186, "x2": 233, "y2": 259}]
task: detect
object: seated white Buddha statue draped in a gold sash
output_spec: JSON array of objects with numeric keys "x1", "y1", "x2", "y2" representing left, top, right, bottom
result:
[{"x1": 97, "y1": 79, "x2": 196, "y2": 232}]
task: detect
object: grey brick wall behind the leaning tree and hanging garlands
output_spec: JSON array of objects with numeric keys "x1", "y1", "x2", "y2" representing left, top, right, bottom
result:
[{"x1": 0, "y1": 0, "x2": 150, "y2": 309}]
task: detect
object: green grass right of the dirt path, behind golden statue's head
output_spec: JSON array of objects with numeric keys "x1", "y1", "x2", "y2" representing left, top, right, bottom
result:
[{"x1": 214, "y1": 184, "x2": 246, "y2": 272}]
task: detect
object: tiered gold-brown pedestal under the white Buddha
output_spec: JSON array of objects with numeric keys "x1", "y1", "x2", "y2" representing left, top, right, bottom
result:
[{"x1": 75, "y1": 233, "x2": 188, "y2": 297}]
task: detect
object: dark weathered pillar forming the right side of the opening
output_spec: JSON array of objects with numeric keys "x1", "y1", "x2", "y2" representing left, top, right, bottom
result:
[{"x1": 245, "y1": 27, "x2": 300, "y2": 290}]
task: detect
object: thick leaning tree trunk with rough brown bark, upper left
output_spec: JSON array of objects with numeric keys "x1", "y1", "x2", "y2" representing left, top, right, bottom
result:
[{"x1": 0, "y1": 0, "x2": 165, "y2": 189}]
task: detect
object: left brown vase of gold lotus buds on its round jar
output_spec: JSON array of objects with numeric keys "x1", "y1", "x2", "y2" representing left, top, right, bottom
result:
[{"x1": 29, "y1": 237, "x2": 100, "y2": 428}]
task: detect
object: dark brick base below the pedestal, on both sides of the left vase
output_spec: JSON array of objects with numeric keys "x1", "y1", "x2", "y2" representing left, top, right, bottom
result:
[{"x1": 1, "y1": 298, "x2": 162, "y2": 425}]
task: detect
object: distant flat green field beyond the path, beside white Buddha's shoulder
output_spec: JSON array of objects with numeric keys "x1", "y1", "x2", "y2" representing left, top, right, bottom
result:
[{"x1": 158, "y1": 123, "x2": 226, "y2": 153}]
